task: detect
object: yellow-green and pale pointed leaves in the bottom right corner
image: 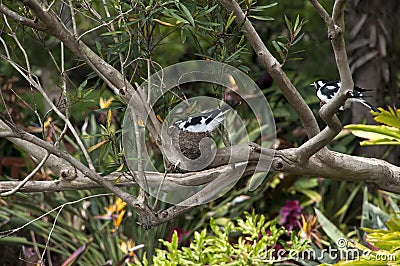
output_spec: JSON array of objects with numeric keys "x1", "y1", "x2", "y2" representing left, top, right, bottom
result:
[{"x1": 316, "y1": 189, "x2": 400, "y2": 265}]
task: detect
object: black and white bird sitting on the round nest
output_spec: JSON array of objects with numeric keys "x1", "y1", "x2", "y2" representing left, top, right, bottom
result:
[{"x1": 174, "y1": 103, "x2": 239, "y2": 133}]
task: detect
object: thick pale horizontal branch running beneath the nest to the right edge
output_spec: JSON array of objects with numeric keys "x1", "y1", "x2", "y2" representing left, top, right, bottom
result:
[{"x1": 0, "y1": 140, "x2": 400, "y2": 193}]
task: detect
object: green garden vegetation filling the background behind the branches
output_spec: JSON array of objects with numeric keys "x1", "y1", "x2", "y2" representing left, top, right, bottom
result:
[{"x1": 0, "y1": 0, "x2": 400, "y2": 265}]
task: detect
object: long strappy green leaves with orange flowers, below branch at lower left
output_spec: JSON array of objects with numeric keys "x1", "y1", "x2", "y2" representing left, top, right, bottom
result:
[{"x1": 0, "y1": 191, "x2": 168, "y2": 265}]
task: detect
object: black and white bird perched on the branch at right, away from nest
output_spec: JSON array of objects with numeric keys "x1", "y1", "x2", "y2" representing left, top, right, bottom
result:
[{"x1": 310, "y1": 79, "x2": 380, "y2": 112}]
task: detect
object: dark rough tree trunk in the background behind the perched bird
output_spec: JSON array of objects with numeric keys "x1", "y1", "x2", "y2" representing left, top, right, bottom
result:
[{"x1": 346, "y1": 0, "x2": 400, "y2": 162}]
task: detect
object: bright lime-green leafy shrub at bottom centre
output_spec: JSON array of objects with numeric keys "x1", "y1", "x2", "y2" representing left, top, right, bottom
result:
[{"x1": 137, "y1": 212, "x2": 309, "y2": 265}]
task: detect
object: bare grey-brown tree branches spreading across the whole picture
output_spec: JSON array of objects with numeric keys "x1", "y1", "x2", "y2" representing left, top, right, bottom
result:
[{"x1": 0, "y1": 0, "x2": 400, "y2": 232}]
